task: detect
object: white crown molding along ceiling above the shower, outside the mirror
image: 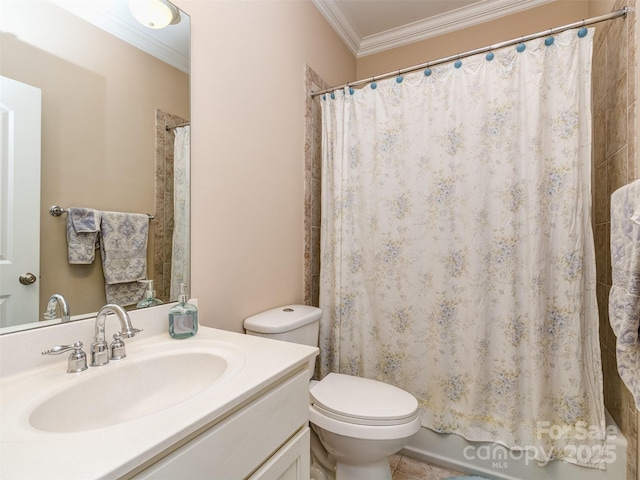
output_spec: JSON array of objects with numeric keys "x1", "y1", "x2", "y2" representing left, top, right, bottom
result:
[{"x1": 312, "y1": 0, "x2": 555, "y2": 58}]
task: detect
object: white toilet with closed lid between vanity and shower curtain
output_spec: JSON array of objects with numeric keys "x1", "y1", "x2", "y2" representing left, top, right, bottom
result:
[{"x1": 244, "y1": 305, "x2": 420, "y2": 480}]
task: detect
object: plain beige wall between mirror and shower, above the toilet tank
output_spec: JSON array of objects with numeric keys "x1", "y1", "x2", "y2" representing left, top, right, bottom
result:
[{"x1": 176, "y1": 0, "x2": 356, "y2": 331}]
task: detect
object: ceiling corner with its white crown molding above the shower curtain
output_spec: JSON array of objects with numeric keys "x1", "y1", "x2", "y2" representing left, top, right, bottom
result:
[{"x1": 311, "y1": 0, "x2": 555, "y2": 57}]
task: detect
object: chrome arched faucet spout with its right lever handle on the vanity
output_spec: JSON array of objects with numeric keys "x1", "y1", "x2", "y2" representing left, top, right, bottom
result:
[{"x1": 91, "y1": 303, "x2": 141, "y2": 367}]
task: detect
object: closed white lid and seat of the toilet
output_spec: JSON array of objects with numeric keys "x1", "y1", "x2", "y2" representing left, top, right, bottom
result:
[{"x1": 309, "y1": 373, "x2": 418, "y2": 425}]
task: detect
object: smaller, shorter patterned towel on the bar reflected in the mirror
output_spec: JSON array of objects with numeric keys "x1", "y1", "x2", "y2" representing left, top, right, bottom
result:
[{"x1": 67, "y1": 207, "x2": 100, "y2": 265}]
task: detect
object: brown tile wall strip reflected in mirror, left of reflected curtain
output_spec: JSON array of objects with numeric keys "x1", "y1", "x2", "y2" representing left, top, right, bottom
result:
[{"x1": 153, "y1": 110, "x2": 186, "y2": 302}]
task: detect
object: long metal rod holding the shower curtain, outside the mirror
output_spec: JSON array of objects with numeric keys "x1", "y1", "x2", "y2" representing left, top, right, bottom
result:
[{"x1": 311, "y1": 6, "x2": 631, "y2": 98}]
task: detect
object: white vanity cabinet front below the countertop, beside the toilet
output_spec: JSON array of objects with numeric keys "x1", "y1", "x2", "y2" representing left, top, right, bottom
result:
[{"x1": 130, "y1": 369, "x2": 310, "y2": 480}]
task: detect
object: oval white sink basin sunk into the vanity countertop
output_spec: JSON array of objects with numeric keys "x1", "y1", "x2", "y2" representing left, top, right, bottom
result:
[{"x1": 28, "y1": 348, "x2": 244, "y2": 433}]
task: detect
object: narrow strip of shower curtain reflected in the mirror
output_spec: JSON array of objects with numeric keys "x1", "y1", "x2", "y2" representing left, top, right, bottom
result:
[{"x1": 170, "y1": 125, "x2": 191, "y2": 301}]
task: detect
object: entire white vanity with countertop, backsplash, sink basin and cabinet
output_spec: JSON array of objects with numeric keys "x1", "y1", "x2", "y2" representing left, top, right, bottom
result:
[{"x1": 0, "y1": 304, "x2": 318, "y2": 480}]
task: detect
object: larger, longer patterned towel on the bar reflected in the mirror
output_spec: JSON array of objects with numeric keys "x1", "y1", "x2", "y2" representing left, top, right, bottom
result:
[{"x1": 100, "y1": 212, "x2": 149, "y2": 307}]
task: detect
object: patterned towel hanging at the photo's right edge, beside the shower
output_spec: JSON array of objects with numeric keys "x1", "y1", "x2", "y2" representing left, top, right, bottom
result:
[{"x1": 609, "y1": 180, "x2": 640, "y2": 409}]
